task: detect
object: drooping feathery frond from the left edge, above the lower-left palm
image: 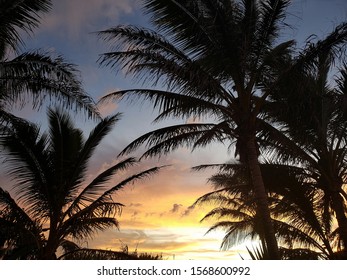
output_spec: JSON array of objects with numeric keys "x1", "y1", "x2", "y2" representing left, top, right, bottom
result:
[{"x1": 0, "y1": 51, "x2": 99, "y2": 118}]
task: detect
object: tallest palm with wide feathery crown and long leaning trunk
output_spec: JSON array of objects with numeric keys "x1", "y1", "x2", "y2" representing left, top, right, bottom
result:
[{"x1": 99, "y1": 0, "x2": 300, "y2": 259}]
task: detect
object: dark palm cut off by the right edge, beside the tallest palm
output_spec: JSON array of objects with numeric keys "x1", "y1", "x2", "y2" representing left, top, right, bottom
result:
[{"x1": 267, "y1": 31, "x2": 347, "y2": 253}]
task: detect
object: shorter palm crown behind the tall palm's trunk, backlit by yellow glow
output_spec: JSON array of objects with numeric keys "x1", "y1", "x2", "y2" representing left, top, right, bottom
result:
[{"x1": 194, "y1": 163, "x2": 339, "y2": 259}]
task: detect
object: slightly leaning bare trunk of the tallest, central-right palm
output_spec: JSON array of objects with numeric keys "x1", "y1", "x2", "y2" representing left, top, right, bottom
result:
[{"x1": 247, "y1": 137, "x2": 280, "y2": 260}]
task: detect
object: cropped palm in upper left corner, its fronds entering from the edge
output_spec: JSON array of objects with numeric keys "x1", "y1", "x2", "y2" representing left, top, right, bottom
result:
[{"x1": 0, "y1": 0, "x2": 98, "y2": 122}]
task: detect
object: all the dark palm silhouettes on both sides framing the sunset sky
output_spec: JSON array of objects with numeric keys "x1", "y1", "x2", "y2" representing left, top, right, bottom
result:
[{"x1": 0, "y1": 0, "x2": 347, "y2": 260}]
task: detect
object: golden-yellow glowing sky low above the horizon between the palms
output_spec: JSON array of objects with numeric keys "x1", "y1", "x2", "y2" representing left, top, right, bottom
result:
[{"x1": 84, "y1": 153, "x2": 250, "y2": 260}]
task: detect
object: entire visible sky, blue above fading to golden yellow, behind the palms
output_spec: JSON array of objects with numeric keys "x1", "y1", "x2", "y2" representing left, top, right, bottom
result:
[{"x1": 0, "y1": 0, "x2": 347, "y2": 259}]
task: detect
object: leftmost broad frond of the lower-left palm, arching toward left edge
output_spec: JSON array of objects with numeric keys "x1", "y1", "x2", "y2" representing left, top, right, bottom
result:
[{"x1": 0, "y1": 116, "x2": 51, "y2": 218}]
